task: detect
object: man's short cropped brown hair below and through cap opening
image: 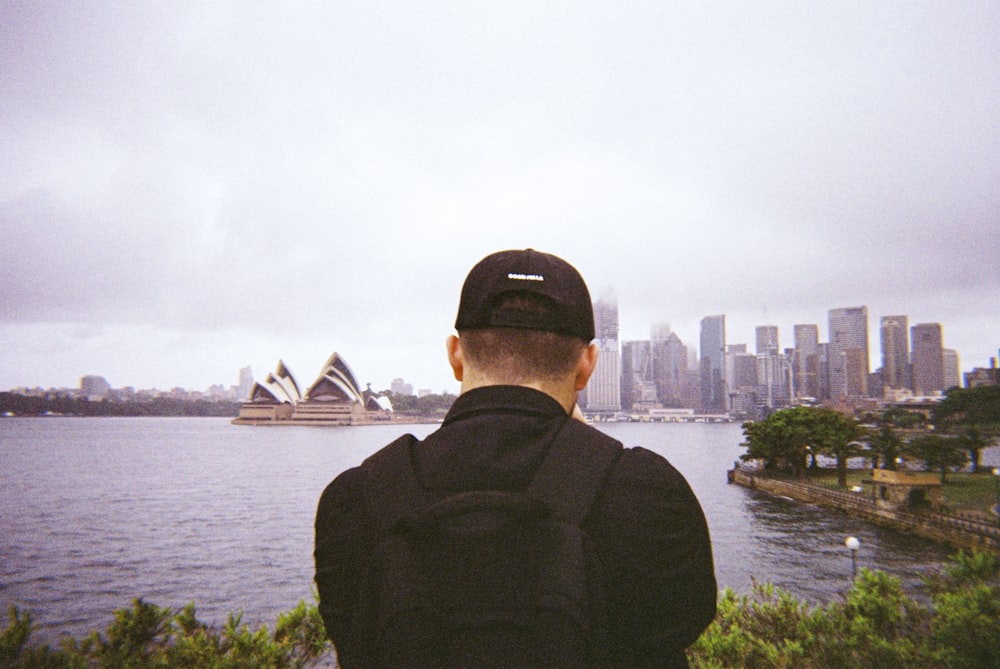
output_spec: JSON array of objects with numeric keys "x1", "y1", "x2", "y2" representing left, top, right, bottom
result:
[{"x1": 459, "y1": 293, "x2": 589, "y2": 384}]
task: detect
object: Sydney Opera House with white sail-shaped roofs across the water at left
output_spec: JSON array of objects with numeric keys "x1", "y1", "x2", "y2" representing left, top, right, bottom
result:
[{"x1": 233, "y1": 353, "x2": 392, "y2": 425}]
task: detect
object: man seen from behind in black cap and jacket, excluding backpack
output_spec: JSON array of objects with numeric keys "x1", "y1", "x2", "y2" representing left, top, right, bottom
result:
[{"x1": 315, "y1": 249, "x2": 717, "y2": 669}]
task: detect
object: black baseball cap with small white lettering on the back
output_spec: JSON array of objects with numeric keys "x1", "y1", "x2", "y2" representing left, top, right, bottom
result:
[{"x1": 455, "y1": 249, "x2": 594, "y2": 342}]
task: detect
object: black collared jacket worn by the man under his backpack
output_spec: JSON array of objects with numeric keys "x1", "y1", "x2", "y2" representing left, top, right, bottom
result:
[{"x1": 315, "y1": 386, "x2": 717, "y2": 669}]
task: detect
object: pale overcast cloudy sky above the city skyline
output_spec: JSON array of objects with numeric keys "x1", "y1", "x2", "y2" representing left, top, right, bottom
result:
[{"x1": 0, "y1": 0, "x2": 1000, "y2": 392}]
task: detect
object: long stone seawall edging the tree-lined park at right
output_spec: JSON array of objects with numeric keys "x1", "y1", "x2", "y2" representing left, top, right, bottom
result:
[{"x1": 727, "y1": 467, "x2": 1000, "y2": 554}]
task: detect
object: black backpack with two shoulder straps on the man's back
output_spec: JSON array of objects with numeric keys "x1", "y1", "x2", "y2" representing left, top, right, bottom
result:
[{"x1": 359, "y1": 420, "x2": 622, "y2": 667}]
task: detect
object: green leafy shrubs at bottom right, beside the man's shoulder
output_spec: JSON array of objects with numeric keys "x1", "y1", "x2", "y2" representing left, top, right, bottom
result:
[{"x1": 689, "y1": 552, "x2": 1000, "y2": 669}]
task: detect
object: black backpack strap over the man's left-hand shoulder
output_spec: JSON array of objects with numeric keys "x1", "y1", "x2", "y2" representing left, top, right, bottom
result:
[{"x1": 363, "y1": 434, "x2": 428, "y2": 536}]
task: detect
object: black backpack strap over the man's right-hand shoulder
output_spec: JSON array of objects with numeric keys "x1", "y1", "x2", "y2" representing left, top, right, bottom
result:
[{"x1": 527, "y1": 418, "x2": 623, "y2": 526}]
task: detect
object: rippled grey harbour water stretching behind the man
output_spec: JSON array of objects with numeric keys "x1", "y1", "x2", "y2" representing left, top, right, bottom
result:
[{"x1": 0, "y1": 418, "x2": 984, "y2": 641}]
